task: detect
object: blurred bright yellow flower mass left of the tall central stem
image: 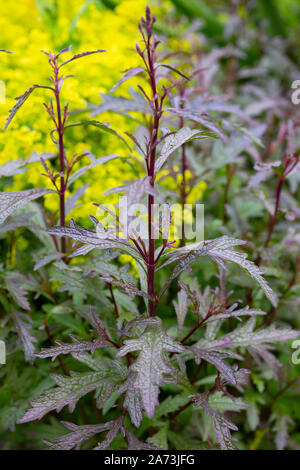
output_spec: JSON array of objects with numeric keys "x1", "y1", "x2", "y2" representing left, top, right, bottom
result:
[{"x1": 0, "y1": 0, "x2": 155, "y2": 221}]
